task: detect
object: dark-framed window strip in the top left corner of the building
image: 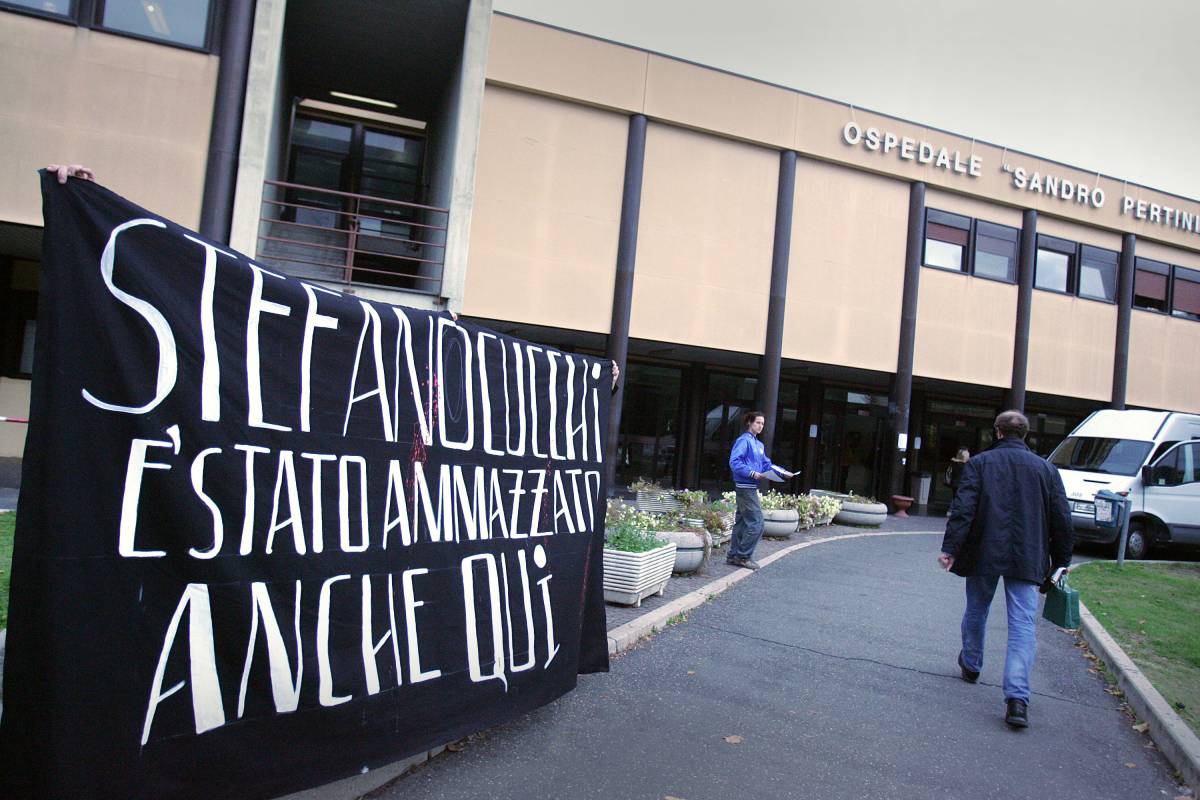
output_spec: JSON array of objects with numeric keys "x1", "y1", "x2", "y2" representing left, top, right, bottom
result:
[{"x1": 0, "y1": 0, "x2": 218, "y2": 50}]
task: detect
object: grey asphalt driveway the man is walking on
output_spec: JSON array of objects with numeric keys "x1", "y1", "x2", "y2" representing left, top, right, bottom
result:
[{"x1": 370, "y1": 535, "x2": 1177, "y2": 800}]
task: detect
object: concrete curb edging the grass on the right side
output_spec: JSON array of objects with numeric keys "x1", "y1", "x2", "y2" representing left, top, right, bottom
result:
[{"x1": 1079, "y1": 602, "x2": 1200, "y2": 792}]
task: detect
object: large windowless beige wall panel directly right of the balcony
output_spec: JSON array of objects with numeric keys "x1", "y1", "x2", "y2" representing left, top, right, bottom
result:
[{"x1": 462, "y1": 85, "x2": 629, "y2": 332}]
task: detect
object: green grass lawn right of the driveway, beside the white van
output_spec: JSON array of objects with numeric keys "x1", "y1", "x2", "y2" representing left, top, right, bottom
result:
[{"x1": 1070, "y1": 561, "x2": 1200, "y2": 734}]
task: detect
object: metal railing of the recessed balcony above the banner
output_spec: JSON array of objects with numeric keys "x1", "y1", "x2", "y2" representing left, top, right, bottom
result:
[{"x1": 256, "y1": 181, "x2": 450, "y2": 295}]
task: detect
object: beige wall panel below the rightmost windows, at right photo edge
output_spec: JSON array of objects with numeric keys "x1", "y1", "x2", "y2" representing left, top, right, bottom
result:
[{"x1": 1126, "y1": 308, "x2": 1200, "y2": 413}]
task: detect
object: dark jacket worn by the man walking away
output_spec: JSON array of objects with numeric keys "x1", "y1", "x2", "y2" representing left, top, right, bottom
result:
[{"x1": 942, "y1": 438, "x2": 1075, "y2": 583}]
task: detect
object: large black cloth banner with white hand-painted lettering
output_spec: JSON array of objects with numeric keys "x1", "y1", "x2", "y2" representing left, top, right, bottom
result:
[{"x1": 0, "y1": 174, "x2": 611, "y2": 799}]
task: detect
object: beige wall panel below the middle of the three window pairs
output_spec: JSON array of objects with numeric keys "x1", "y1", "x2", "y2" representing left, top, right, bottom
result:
[{"x1": 1025, "y1": 289, "x2": 1117, "y2": 402}]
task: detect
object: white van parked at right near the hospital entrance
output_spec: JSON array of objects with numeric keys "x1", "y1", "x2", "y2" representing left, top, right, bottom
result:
[{"x1": 1049, "y1": 409, "x2": 1200, "y2": 559}]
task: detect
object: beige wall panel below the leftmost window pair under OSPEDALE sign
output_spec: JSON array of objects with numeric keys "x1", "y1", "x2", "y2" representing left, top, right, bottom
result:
[{"x1": 912, "y1": 267, "x2": 1016, "y2": 387}]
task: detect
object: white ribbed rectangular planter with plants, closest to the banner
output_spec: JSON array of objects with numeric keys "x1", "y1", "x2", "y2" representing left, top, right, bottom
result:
[{"x1": 604, "y1": 513, "x2": 676, "y2": 606}]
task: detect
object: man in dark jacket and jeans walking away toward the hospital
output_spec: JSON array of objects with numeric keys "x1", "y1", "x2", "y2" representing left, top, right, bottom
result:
[{"x1": 937, "y1": 411, "x2": 1074, "y2": 728}]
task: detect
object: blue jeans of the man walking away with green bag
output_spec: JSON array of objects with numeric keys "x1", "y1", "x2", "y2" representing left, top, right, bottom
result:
[{"x1": 962, "y1": 576, "x2": 1038, "y2": 703}]
